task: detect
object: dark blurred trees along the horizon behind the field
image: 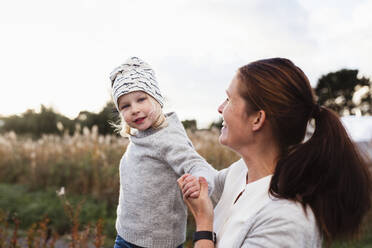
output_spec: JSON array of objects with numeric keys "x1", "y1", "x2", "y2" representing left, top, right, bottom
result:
[{"x1": 0, "y1": 69, "x2": 372, "y2": 138}]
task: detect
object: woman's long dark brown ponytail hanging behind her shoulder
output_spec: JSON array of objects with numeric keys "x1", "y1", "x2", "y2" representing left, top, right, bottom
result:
[{"x1": 269, "y1": 105, "x2": 371, "y2": 244}]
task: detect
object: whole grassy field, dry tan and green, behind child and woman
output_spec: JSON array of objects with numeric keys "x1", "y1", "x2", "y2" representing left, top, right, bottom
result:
[{"x1": 0, "y1": 127, "x2": 372, "y2": 248}]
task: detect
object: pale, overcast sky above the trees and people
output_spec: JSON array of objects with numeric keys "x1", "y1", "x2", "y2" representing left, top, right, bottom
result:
[{"x1": 0, "y1": 0, "x2": 372, "y2": 127}]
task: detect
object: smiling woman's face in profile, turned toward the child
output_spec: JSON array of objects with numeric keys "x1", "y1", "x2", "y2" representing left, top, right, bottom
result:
[{"x1": 218, "y1": 74, "x2": 251, "y2": 151}]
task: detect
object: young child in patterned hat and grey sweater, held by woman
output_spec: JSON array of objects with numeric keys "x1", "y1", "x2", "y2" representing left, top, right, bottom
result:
[{"x1": 110, "y1": 57, "x2": 216, "y2": 248}]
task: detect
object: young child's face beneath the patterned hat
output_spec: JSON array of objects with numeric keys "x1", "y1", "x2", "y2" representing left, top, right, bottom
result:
[{"x1": 118, "y1": 91, "x2": 160, "y2": 131}]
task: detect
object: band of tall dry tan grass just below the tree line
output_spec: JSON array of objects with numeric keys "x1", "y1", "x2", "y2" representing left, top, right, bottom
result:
[{"x1": 0, "y1": 127, "x2": 238, "y2": 206}]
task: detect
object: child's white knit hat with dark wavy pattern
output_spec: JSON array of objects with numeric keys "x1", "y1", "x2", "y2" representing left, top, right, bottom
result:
[{"x1": 110, "y1": 57, "x2": 164, "y2": 111}]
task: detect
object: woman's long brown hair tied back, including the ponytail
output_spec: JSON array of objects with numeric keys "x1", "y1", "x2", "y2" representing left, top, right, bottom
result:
[{"x1": 238, "y1": 58, "x2": 371, "y2": 244}]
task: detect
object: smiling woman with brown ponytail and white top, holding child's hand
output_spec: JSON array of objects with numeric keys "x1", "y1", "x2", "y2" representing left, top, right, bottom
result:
[{"x1": 178, "y1": 58, "x2": 371, "y2": 248}]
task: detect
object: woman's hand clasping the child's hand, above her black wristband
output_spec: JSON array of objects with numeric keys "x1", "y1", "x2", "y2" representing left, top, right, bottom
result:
[{"x1": 177, "y1": 174, "x2": 213, "y2": 231}]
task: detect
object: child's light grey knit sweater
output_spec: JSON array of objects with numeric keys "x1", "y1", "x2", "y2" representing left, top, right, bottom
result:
[{"x1": 116, "y1": 113, "x2": 217, "y2": 248}]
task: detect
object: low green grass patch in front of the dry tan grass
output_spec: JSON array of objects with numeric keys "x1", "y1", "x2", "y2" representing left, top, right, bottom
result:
[{"x1": 0, "y1": 184, "x2": 116, "y2": 247}]
